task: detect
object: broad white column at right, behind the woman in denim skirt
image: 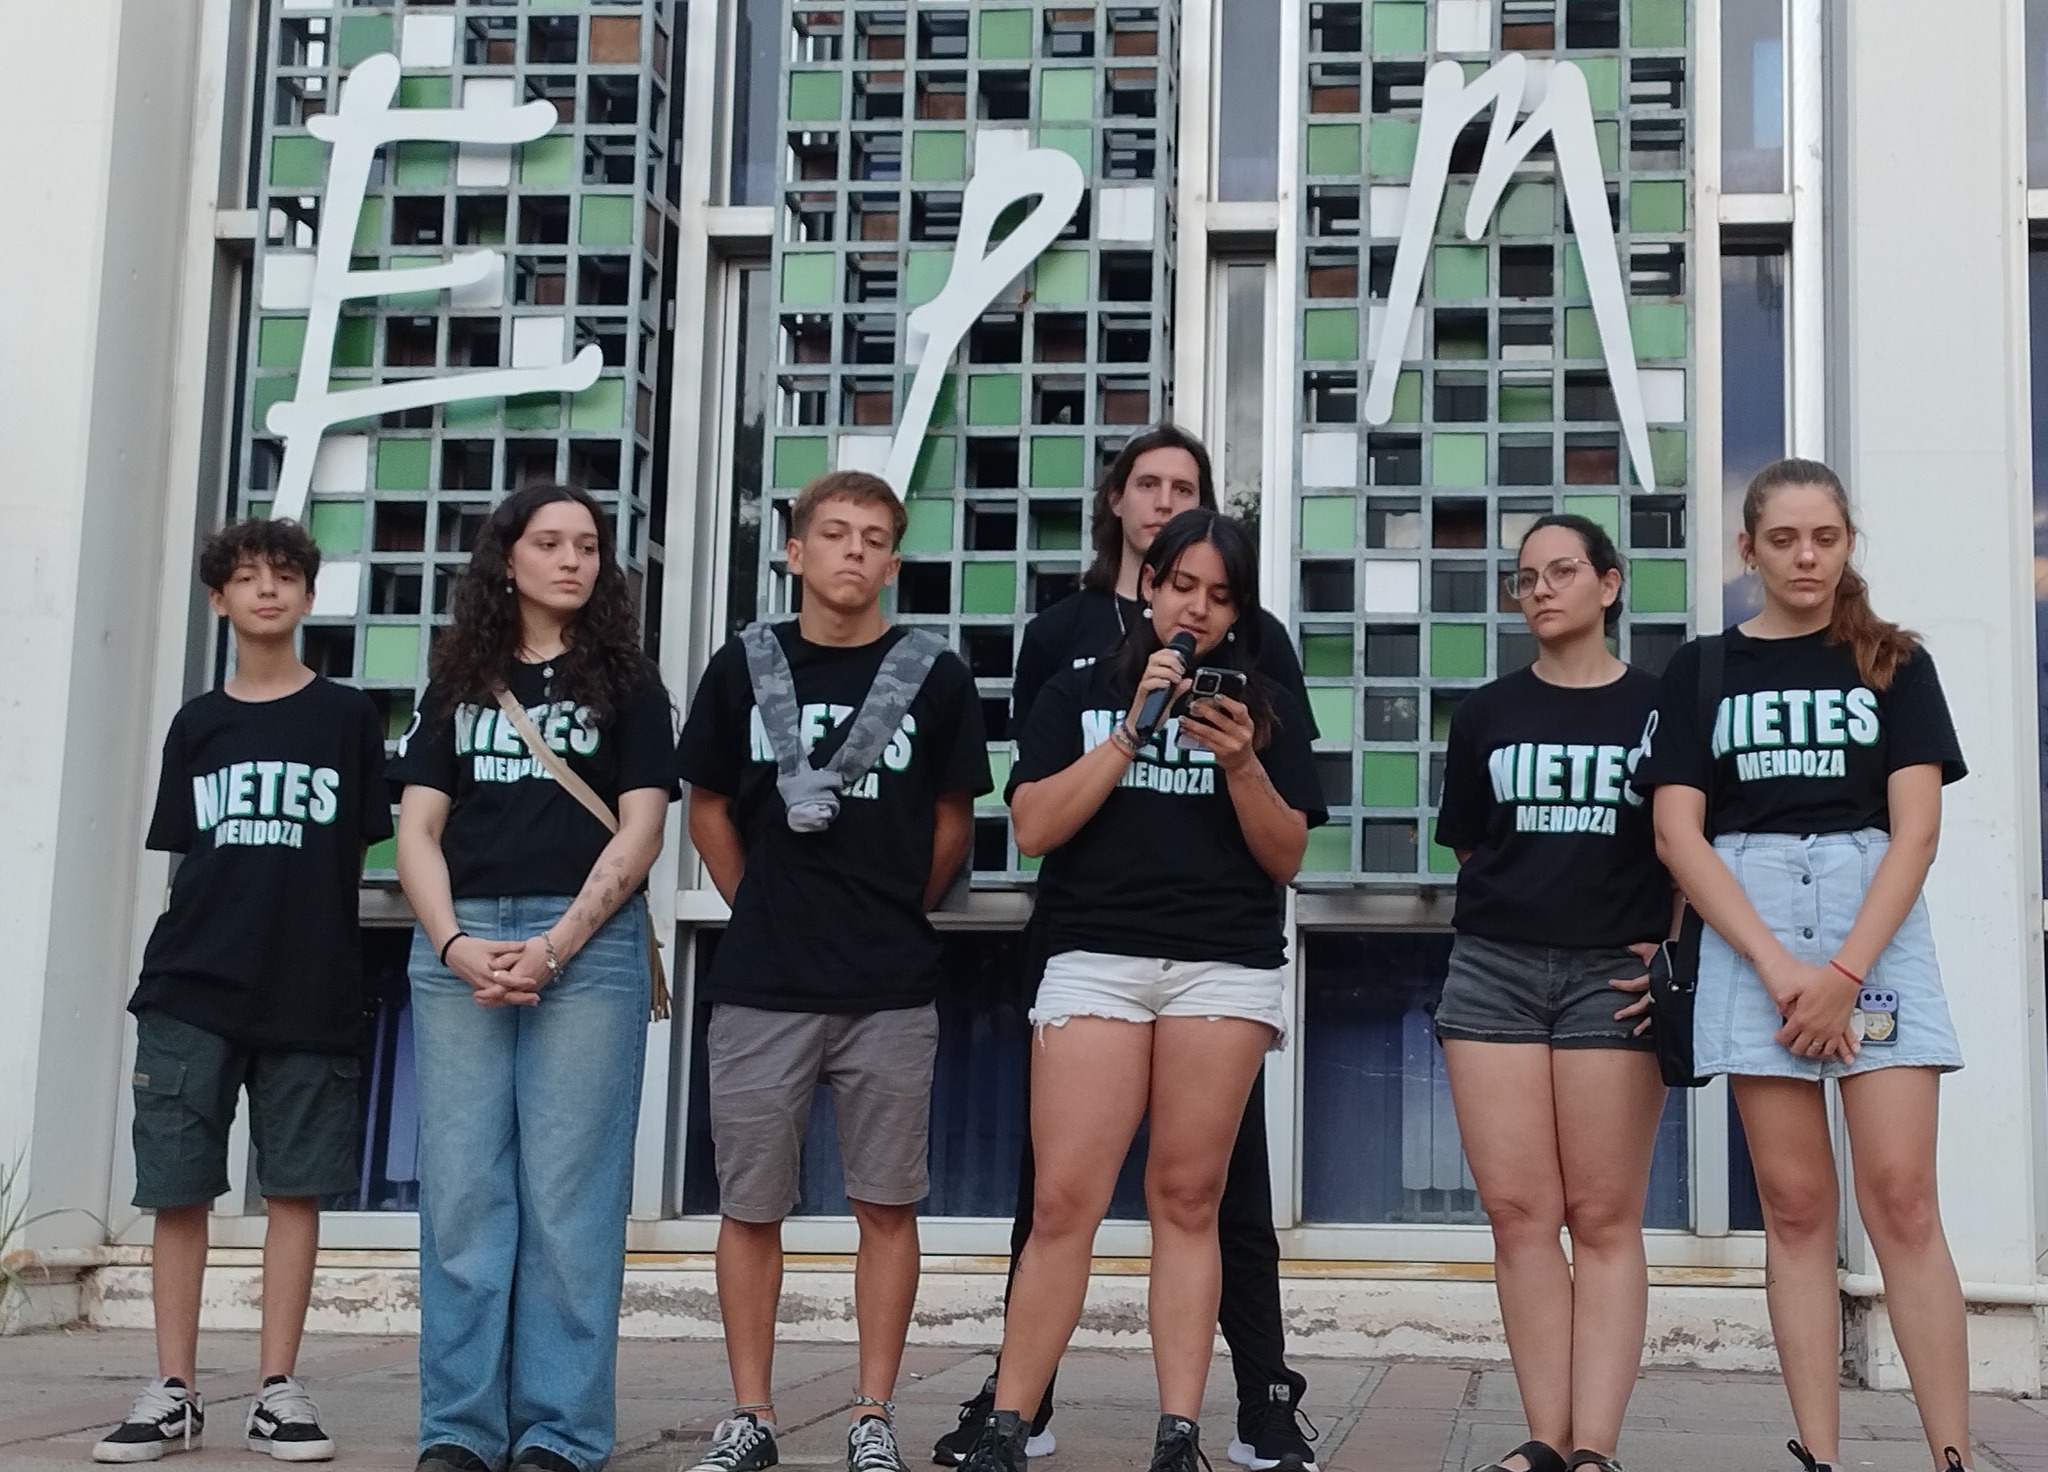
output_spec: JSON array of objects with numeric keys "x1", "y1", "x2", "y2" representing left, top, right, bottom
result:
[{"x1": 1827, "y1": 0, "x2": 2044, "y2": 1394}]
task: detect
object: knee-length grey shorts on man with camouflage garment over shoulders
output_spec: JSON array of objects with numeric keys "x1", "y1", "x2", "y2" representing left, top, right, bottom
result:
[{"x1": 705, "y1": 1001, "x2": 938, "y2": 1222}]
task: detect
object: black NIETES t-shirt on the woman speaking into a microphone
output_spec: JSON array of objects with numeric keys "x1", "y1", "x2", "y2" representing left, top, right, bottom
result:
[{"x1": 1006, "y1": 659, "x2": 1329, "y2": 966}]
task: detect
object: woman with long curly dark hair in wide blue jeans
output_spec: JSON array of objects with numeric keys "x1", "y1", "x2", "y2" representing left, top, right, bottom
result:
[{"x1": 389, "y1": 485, "x2": 676, "y2": 1472}]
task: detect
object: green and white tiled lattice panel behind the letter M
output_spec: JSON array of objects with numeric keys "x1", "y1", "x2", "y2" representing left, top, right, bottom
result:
[{"x1": 1294, "y1": 0, "x2": 1700, "y2": 886}]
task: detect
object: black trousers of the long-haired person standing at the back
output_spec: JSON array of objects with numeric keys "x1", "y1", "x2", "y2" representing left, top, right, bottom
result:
[{"x1": 1004, "y1": 1035, "x2": 1294, "y2": 1406}]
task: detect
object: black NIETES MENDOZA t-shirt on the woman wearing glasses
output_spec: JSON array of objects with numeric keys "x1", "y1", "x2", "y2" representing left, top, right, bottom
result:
[{"x1": 1436, "y1": 669, "x2": 1671, "y2": 948}]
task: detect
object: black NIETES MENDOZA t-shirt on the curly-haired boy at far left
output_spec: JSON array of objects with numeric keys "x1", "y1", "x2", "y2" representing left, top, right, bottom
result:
[{"x1": 129, "y1": 676, "x2": 391, "y2": 1052}]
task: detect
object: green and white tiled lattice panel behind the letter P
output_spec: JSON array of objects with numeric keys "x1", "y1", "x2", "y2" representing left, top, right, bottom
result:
[{"x1": 753, "y1": 0, "x2": 1179, "y2": 880}]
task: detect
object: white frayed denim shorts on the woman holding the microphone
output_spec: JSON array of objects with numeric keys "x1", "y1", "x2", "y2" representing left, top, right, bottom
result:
[{"x1": 1030, "y1": 950, "x2": 1286, "y2": 1048}]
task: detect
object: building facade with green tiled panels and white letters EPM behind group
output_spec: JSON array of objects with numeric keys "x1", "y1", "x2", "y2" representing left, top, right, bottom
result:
[{"x1": 0, "y1": 0, "x2": 2048, "y2": 1390}]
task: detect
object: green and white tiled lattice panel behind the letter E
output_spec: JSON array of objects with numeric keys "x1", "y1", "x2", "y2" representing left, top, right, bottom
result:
[{"x1": 227, "y1": 0, "x2": 671, "y2": 882}]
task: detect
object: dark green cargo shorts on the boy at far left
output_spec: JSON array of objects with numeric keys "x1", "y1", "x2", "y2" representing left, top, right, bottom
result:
[{"x1": 135, "y1": 1009, "x2": 362, "y2": 1210}]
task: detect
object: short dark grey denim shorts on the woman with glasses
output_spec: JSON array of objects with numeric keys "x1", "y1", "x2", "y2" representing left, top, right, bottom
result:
[{"x1": 1436, "y1": 936, "x2": 1653, "y2": 1048}]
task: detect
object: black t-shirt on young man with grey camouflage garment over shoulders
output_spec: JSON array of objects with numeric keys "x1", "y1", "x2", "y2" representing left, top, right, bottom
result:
[{"x1": 680, "y1": 620, "x2": 993, "y2": 1011}]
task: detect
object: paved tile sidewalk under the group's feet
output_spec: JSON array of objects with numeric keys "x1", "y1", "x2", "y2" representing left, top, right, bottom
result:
[{"x1": 0, "y1": 1329, "x2": 2048, "y2": 1472}]
